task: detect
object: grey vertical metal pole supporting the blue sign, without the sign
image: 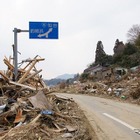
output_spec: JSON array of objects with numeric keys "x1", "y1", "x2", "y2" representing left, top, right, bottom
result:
[{"x1": 13, "y1": 28, "x2": 18, "y2": 81}]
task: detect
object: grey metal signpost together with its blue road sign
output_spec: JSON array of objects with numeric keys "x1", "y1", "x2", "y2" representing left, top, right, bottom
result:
[{"x1": 13, "y1": 22, "x2": 58, "y2": 81}]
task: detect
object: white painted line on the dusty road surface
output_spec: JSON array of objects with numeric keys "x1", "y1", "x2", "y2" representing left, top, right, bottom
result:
[{"x1": 103, "y1": 113, "x2": 136, "y2": 130}]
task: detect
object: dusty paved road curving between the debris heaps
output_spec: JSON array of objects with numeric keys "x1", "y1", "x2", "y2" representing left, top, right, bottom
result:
[{"x1": 57, "y1": 93, "x2": 140, "y2": 140}]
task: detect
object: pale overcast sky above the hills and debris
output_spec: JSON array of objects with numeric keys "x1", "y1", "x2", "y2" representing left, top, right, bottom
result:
[{"x1": 0, "y1": 0, "x2": 140, "y2": 79}]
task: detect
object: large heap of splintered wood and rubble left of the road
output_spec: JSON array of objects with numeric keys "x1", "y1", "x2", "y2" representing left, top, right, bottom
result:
[{"x1": 0, "y1": 56, "x2": 92, "y2": 140}]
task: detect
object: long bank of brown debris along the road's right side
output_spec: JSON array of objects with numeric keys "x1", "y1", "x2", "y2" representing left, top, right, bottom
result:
[{"x1": 57, "y1": 71, "x2": 140, "y2": 104}]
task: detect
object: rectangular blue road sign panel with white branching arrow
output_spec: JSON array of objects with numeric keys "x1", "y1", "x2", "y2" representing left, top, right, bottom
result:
[{"x1": 29, "y1": 22, "x2": 58, "y2": 39}]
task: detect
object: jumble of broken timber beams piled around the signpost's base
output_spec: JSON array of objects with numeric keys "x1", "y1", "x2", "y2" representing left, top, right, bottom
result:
[{"x1": 0, "y1": 56, "x2": 48, "y2": 91}]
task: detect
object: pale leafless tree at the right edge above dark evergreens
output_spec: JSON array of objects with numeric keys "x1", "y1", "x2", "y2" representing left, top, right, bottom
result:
[{"x1": 127, "y1": 24, "x2": 140, "y2": 44}]
